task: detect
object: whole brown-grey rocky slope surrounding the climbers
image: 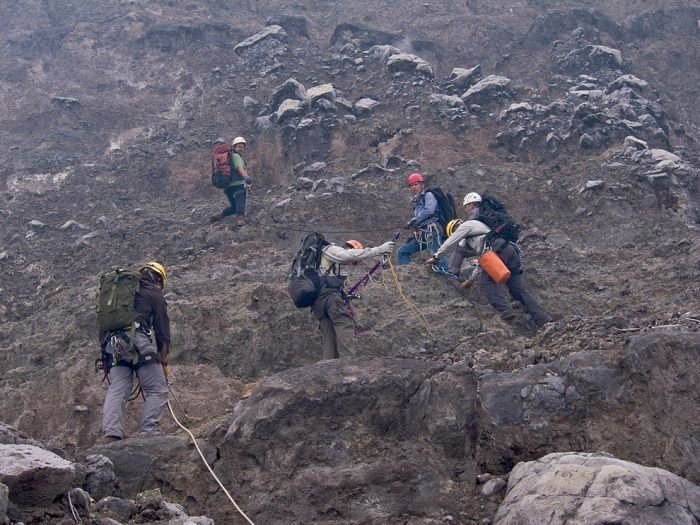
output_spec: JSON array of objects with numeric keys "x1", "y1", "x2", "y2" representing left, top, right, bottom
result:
[{"x1": 0, "y1": 0, "x2": 700, "y2": 524}]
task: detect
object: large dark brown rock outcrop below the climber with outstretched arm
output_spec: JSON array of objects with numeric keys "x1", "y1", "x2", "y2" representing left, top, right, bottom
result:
[{"x1": 217, "y1": 359, "x2": 476, "y2": 523}]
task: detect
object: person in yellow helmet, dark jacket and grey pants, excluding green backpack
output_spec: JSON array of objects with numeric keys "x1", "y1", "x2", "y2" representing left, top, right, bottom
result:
[{"x1": 102, "y1": 262, "x2": 170, "y2": 441}]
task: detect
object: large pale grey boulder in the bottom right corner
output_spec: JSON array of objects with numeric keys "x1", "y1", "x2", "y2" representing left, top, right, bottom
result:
[{"x1": 493, "y1": 452, "x2": 700, "y2": 525}]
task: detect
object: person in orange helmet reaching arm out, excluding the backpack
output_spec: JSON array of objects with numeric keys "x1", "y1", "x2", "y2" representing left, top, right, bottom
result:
[{"x1": 311, "y1": 240, "x2": 394, "y2": 359}]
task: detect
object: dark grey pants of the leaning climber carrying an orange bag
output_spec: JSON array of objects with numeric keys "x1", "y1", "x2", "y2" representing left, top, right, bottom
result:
[{"x1": 479, "y1": 244, "x2": 552, "y2": 326}]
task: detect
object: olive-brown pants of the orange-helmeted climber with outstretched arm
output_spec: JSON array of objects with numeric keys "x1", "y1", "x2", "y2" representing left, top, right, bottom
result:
[{"x1": 313, "y1": 293, "x2": 357, "y2": 359}]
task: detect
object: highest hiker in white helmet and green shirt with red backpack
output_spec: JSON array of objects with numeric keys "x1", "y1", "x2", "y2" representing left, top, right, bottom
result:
[{"x1": 210, "y1": 137, "x2": 252, "y2": 224}]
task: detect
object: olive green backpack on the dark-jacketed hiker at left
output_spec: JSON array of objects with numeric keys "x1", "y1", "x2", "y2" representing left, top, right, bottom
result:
[{"x1": 96, "y1": 268, "x2": 141, "y2": 343}]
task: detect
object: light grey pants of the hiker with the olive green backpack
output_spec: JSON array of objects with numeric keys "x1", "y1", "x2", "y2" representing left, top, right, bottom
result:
[{"x1": 102, "y1": 331, "x2": 168, "y2": 439}]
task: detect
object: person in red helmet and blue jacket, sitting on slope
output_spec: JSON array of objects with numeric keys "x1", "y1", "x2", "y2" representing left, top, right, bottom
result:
[{"x1": 396, "y1": 173, "x2": 447, "y2": 268}]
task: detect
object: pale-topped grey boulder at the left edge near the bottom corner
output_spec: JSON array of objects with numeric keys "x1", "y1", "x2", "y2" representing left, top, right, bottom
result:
[{"x1": 0, "y1": 445, "x2": 76, "y2": 506}]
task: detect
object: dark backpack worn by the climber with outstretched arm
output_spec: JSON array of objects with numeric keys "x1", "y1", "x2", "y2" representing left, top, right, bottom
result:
[{"x1": 287, "y1": 232, "x2": 330, "y2": 308}]
